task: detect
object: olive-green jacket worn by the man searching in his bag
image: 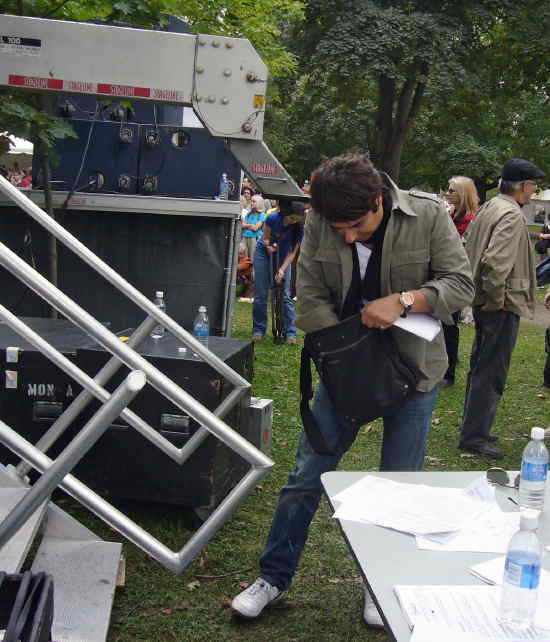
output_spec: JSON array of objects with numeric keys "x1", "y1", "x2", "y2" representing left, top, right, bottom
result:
[{"x1": 296, "y1": 181, "x2": 474, "y2": 392}]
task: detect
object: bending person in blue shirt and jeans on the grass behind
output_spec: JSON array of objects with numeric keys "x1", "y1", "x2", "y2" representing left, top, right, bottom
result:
[{"x1": 252, "y1": 201, "x2": 304, "y2": 343}]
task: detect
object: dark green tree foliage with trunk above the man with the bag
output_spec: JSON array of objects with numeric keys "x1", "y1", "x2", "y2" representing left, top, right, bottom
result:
[{"x1": 271, "y1": 0, "x2": 550, "y2": 187}]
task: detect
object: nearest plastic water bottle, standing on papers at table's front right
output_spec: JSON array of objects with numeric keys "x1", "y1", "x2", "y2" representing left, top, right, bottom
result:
[{"x1": 500, "y1": 508, "x2": 542, "y2": 629}]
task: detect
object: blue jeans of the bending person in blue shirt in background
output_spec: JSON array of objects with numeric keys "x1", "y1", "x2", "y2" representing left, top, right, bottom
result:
[{"x1": 252, "y1": 247, "x2": 296, "y2": 337}]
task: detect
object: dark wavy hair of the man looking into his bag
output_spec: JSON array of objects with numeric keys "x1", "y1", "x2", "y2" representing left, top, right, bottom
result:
[{"x1": 310, "y1": 154, "x2": 388, "y2": 222}]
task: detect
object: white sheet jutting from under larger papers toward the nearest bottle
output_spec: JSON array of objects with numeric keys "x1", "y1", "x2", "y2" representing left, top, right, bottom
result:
[{"x1": 416, "y1": 505, "x2": 519, "y2": 553}]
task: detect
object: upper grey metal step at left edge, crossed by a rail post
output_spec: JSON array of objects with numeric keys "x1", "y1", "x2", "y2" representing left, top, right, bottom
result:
[{"x1": 0, "y1": 487, "x2": 48, "y2": 573}]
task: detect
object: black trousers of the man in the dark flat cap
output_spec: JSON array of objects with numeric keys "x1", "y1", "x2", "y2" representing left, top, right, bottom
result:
[{"x1": 460, "y1": 307, "x2": 519, "y2": 448}]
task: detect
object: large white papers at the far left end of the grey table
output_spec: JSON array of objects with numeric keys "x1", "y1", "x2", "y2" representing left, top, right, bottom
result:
[{"x1": 332, "y1": 475, "x2": 490, "y2": 535}]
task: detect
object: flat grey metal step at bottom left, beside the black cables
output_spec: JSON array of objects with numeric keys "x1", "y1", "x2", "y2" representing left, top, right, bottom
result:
[{"x1": 32, "y1": 536, "x2": 122, "y2": 642}]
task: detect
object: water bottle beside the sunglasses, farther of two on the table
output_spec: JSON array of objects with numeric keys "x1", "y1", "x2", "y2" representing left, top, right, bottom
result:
[{"x1": 519, "y1": 427, "x2": 548, "y2": 511}]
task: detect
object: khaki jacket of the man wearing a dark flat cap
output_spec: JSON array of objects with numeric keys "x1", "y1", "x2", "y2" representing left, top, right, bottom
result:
[{"x1": 466, "y1": 194, "x2": 536, "y2": 318}]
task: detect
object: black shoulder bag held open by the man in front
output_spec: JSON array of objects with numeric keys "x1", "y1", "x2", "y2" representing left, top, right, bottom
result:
[{"x1": 300, "y1": 314, "x2": 416, "y2": 455}]
